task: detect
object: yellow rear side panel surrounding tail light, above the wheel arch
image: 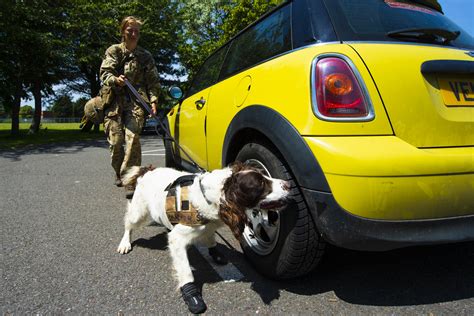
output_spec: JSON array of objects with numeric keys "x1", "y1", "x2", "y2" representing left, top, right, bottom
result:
[{"x1": 207, "y1": 44, "x2": 393, "y2": 169}]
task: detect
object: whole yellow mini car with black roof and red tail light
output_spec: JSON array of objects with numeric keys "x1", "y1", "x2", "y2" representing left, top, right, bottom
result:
[{"x1": 165, "y1": 0, "x2": 474, "y2": 278}]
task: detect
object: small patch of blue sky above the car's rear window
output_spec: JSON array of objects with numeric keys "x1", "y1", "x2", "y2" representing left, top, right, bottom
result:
[{"x1": 438, "y1": 0, "x2": 474, "y2": 37}]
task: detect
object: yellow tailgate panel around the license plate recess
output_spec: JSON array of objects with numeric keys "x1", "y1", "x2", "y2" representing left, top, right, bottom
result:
[{"x1": 351, "y1": 43, "x2": 474, "y2": 147}]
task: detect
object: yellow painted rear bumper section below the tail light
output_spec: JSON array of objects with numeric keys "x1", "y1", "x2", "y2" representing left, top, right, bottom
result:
[{"x1": 305, "y1": 136, "x2": 474, "y2": 220}]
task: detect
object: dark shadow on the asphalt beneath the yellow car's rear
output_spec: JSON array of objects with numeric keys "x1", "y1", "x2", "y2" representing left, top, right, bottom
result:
[{"x1": 193, "y1": 242, "x2": 474, "y2": 306}]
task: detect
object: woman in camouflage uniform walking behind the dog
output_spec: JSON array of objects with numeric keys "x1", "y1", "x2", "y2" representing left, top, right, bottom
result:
[{"x1": 100, "y1": 16, "x2": 160, "y2": 198}]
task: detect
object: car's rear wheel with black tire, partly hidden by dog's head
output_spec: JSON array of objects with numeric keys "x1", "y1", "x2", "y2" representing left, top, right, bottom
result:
[{"x1": 236, "y1": 143, "x2": 326, "y2": 279}]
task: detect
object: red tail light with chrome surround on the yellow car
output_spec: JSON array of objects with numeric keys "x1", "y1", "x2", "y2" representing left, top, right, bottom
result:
[{"x1": 313, "y1": 57, "x2": 373, "y2": 120}]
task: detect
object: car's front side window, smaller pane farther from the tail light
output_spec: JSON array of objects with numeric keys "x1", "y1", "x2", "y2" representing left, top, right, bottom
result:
[{"x1": 186, "y1": 45, "x2": 229, "y2": 96}]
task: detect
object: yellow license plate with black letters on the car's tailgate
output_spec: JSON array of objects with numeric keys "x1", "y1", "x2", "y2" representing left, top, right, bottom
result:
[{"x1": 438, "y1": 78, "x2": 474, "y2": 106}]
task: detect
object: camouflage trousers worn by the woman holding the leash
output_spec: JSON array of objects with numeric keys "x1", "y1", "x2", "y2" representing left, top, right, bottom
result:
[{"x1": 104, "y1": 106, "x2": 144, "y2": 177}]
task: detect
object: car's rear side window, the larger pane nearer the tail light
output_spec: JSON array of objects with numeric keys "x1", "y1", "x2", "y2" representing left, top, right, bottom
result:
[{"x1": 220, "y1": 5, "x2": 291, "y2": 79}]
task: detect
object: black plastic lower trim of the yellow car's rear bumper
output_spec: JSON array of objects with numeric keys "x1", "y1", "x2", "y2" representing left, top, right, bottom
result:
[{"x1": 302, "y1": 188, "x2": 474, "y2": 251}]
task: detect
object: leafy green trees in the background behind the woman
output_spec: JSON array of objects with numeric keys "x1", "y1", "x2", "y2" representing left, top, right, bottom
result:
[{"x1": 0, "y1": 0, "x2": 282, "y2": 135}]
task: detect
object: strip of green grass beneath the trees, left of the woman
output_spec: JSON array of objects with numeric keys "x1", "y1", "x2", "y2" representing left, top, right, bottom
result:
[{"x1": 0, "y1": 123, "x2": 105, "y2": 149}]
